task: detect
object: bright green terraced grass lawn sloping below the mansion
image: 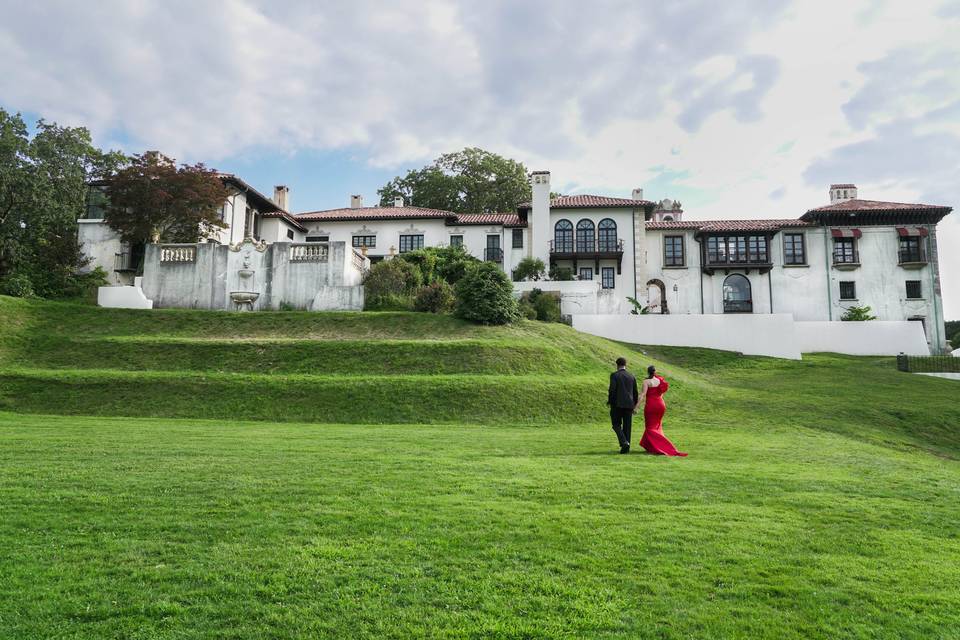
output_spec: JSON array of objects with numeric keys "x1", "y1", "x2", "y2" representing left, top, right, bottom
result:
[{"x1": 0, "y1": 297, "x2": 960, "y2": 638}]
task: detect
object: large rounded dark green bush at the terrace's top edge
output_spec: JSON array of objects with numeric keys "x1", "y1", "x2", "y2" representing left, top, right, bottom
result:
[{"x1": 454, "y1": 262, "x2": 520, "y2": 324}]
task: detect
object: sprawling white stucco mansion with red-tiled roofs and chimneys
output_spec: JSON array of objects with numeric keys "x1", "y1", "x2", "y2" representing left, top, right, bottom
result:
[{"x1": 80, "y1": 171, "x2": 951, "y2": 351}]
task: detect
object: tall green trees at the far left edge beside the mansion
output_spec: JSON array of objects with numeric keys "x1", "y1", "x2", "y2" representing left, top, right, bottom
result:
[{"x1": 0, "y1": 109, "x2": 125, "y2": 297}]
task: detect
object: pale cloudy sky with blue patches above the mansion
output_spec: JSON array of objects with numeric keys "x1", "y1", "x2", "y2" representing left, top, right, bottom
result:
[{"x1": 0, "y1": 0, "x2": 960, "y2": 319}]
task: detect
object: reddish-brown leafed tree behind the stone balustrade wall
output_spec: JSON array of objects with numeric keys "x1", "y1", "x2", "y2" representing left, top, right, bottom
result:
[{"x1": 104, "y1": 151, "x2": 228, "y2": 243}]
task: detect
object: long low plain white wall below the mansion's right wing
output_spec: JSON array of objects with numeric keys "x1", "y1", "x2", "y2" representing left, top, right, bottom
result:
[{"x1": 573, "y1": 314, "x2": 930, "y2": 360}]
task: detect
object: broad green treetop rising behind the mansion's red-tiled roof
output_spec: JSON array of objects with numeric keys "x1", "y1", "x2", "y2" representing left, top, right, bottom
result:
[{"x1": 377, "y1": 147, "x2": 531, "y2": 213}]
